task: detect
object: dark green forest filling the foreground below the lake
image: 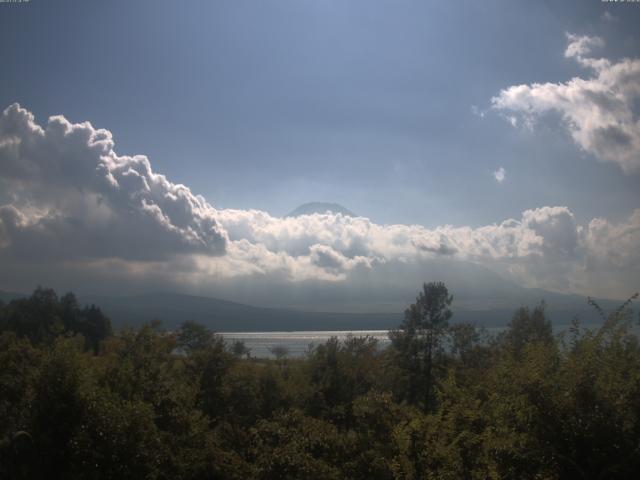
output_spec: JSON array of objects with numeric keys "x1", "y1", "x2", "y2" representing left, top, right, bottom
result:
[{"x1": 0, "y1": 283, "x2": 640, "y2": 479}]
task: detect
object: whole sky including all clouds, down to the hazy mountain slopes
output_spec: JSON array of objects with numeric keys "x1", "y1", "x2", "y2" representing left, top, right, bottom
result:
[{"x1": 0, "y1": 0, "x2": 640, "y2": 305}]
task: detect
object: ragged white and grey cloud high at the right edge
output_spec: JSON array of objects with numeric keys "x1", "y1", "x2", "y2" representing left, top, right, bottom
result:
[{"x1": 491, "y1": 34, "x2": 640, "y2": 174}]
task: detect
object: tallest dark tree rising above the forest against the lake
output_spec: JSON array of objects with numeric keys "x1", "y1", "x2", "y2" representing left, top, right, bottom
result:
[{"x1": 389, "y1": 282, "x2": 453, "y2": 410}]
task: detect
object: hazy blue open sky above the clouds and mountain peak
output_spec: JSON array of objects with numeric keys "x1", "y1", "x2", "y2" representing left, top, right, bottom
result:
[{"x1": 0, "y1": 0, "x2": 640, "y2": 306}]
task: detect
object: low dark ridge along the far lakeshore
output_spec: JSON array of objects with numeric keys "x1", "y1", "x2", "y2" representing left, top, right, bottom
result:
[{"x1": 74, "y1": 291, "x2": 619, "y2": 332}]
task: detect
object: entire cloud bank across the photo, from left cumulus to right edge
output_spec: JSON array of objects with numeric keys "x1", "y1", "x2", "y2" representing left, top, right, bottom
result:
[{"x1": 0, "y1": 104, "x2": 640, "y2": 297}]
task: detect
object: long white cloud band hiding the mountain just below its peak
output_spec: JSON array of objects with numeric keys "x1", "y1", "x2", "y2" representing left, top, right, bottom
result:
[{"x1": 215, "y1": 202, "x2": 640, "y2": 296}]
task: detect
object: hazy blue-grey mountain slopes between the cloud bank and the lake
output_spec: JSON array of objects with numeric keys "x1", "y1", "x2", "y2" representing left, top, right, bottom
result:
[{"x1": 0, "y1": 280, "x2": 621, "y2": 331}]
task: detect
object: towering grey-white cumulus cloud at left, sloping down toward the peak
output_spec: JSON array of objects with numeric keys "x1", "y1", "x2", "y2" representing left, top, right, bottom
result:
[{"x1": 0, "y1": 104, "x2": 227, "y2": 259}]
